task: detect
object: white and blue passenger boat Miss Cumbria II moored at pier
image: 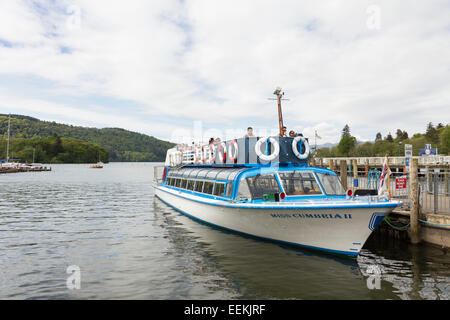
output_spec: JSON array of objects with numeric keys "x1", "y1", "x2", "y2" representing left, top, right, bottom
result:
[{"x1": 155, "y1": 137, "x2": 401, "y2": 256}]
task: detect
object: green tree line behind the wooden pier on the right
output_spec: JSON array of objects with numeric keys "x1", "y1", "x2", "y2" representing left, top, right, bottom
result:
[{"x1": 317, "y1": 122, "x2": 450, "y2": 158}]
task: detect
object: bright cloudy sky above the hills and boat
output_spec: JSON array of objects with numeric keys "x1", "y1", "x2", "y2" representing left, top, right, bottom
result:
[{"x1": 0, "y1": 0, "x2": 450, "y2": 143}]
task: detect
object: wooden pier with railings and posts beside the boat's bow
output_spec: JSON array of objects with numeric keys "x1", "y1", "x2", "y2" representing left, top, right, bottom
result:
[{"x1": 310, "y1": 156, "x2": 450, "y2": 248}]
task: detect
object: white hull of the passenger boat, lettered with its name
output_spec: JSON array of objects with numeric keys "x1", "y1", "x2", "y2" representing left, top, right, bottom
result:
[{"x1": 155, "y1": 187, "x2": 393, "y2": 257}]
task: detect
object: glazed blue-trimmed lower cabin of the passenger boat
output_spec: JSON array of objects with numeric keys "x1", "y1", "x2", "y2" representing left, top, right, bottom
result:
[{"x1": 163, "y1": 166, "x2": 346, "y2": 202}]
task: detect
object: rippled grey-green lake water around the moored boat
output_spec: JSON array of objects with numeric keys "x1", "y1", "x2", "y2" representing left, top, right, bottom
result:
[{"x1": 0, "y1": 163, "x2": 450, "y2": 299}]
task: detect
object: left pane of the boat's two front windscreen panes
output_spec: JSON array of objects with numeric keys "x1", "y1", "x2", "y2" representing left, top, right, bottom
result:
[{"x1": 278, "y1": 171, "x2": 322, "y2": 196}]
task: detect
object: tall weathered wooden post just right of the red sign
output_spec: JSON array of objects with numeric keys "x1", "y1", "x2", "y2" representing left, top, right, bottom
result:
[{"x1": 409, "y1": 158, "x2": 420, "y2": 244}]
